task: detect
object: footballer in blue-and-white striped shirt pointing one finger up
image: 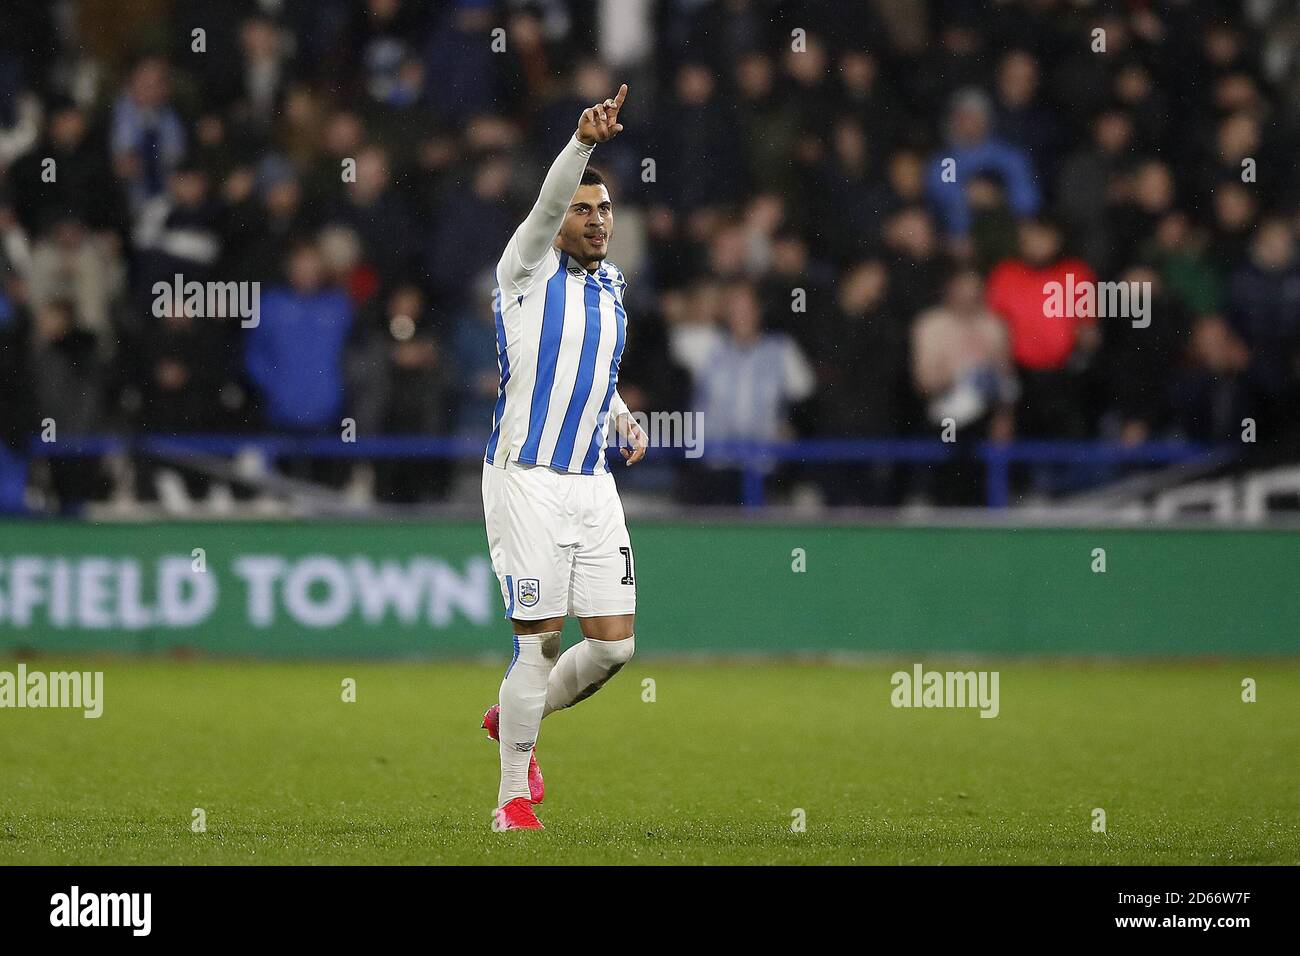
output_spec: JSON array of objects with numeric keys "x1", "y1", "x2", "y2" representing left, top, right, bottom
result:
[{"x1": 482, "y1": 83, "x2": 646, "y2": 830}]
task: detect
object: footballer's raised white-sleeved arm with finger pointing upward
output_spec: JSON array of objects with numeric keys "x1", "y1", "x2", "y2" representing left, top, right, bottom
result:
[{"x1": 497, "y1": 83, "x2": 628, "y2": 291}]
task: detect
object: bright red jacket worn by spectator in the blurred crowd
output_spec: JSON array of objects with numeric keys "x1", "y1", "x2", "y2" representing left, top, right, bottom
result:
[{"x1": 984, "y1": 259, "x2": 1096, "y2": 371}]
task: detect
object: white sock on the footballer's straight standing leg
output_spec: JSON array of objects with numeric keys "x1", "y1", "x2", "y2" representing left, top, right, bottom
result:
[{"x1": 497, "y1": 631, "x2": 560, "y2": 806}]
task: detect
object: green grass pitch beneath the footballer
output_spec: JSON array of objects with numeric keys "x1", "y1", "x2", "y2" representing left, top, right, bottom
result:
[{"x1": 0, "y1": 656, "x2": 1300, "y2": 864}]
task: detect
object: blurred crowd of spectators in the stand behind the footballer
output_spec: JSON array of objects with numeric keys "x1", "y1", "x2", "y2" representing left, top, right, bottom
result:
[{"x1": 0, "y1": 0, "x2": 1300, "y2": 512}]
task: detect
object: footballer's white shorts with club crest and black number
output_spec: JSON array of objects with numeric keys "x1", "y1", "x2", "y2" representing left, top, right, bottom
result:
[{"x1": 484, "y1": 462, "x2": 637, "y2": 620}]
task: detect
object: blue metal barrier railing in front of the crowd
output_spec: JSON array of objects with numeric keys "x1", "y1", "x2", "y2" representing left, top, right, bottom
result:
[{"x1": 15, "y1": 434, "x2": 1218, "y2": 509}]
